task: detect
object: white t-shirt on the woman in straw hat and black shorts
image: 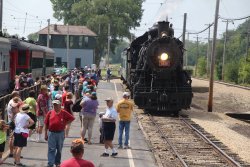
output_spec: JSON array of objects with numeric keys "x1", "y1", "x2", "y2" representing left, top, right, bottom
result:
[{"x1": 14, "y1": 113, "x2": 30, "y2": 134}]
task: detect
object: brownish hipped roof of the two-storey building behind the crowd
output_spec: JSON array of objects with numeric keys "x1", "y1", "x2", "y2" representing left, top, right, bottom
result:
[{"x1": 37, "y1": 24, "x2": 97, "y2": 36}]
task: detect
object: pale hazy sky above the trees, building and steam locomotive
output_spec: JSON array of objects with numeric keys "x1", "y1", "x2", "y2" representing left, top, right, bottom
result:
[{"x1": 3, "y1": 0, "x2": 250, "y2": 40}]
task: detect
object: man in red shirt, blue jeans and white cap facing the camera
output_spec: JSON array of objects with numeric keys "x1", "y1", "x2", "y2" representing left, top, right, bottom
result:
[{"x1": 44, "y1": 100, "x2": 75, "y2": 167}]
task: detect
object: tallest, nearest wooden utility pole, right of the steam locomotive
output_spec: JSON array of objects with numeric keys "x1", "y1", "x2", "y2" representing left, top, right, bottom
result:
[{"x1": 207, "y1": 0, "x2": 220, "y2": 112}]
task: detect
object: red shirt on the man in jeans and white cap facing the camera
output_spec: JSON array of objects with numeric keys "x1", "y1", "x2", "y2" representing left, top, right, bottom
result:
[{"x1": 44, "y1": 110, "x2": 75, "y2": 131}]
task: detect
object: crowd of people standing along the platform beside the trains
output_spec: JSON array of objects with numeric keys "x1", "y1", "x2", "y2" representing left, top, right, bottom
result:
[{"x1": 0, "y1": 69, "x2": 133, "y2": 167}]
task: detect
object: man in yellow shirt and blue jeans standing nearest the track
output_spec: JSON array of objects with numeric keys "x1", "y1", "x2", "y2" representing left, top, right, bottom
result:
[{"x1": 116, "y1": 92, "x2": 134, "y2": 149}]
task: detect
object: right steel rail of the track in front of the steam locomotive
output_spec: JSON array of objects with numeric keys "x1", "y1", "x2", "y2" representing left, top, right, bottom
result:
[{"x1": 180, "y1": 116, "x2": 241, "y2": 167}]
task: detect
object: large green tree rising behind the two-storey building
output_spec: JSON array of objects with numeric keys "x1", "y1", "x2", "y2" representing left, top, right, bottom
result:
[{"x1": 51, "y1": 0, "x2": 144, "y2": 64}]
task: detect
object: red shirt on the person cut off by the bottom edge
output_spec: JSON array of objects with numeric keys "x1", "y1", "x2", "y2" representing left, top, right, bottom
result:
[{"x1": 60, "y1": 157, "x2": 95, "y2": 167}]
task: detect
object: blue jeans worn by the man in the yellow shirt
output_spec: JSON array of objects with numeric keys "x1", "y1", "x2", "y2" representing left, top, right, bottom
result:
[{"x1": 118, "y1": 121, "x2": 130, "y2": 146}]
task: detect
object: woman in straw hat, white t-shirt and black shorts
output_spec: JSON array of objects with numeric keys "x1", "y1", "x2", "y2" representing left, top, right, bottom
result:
[{"x1": 14, "y1": 104, "x2": 34, "y2": 166}]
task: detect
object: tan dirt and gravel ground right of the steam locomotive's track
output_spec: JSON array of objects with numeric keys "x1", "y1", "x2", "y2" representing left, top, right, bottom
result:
[{"x1": 187, "y1": 79, "x2": 250, "y2": 164}]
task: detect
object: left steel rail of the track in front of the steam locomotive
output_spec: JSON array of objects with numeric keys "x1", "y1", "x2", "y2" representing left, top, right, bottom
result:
[{"x1": 148, "y1": 114, "x2": 188, "y2": 167}]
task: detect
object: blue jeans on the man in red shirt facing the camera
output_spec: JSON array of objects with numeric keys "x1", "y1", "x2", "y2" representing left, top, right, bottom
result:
[{"x1": 48, "y1": 131, "x2": 64, "y2": 166}]
